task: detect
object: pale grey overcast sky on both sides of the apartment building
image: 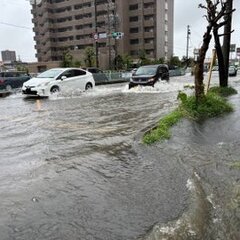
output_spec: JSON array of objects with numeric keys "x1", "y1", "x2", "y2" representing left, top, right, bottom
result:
[{"x1": 0, "y1": 0, "x2": 240, "y2": 62}]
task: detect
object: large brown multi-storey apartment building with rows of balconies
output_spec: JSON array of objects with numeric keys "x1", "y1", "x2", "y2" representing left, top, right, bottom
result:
[{"x1": 31, "y1": 0, "x2": 174, "y2": 68}]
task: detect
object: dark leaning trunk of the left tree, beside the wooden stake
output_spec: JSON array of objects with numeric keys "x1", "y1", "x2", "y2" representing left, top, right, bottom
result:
[{"x1": 195, "y1": 26, "x2": 212, "y2": 102}]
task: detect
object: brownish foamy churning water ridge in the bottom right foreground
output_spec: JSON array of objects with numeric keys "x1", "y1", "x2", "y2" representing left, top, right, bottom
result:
[{"x1": 139, "y1": 172, "x2": 212, "y2": 240}]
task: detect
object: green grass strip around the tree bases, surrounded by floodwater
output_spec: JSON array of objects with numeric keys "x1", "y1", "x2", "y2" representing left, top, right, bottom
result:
[{"x1": 143, "y1": 88, "x2": 236, "y2": 144}]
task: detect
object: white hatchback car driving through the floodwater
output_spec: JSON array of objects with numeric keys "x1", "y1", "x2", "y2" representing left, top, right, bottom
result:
[{"x1": 22, "y1": 68, "x2": 95, "y2": 97}]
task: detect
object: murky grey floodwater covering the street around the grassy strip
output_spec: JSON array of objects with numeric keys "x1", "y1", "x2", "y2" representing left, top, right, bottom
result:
[{"x1": 0, "y1": 76, "x2": 240, "y2": 240}]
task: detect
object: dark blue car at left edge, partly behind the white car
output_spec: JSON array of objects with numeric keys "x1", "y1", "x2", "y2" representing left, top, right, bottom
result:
[{"x1": 0, "y1": 71, "x2": 31, "y2": 91}]
